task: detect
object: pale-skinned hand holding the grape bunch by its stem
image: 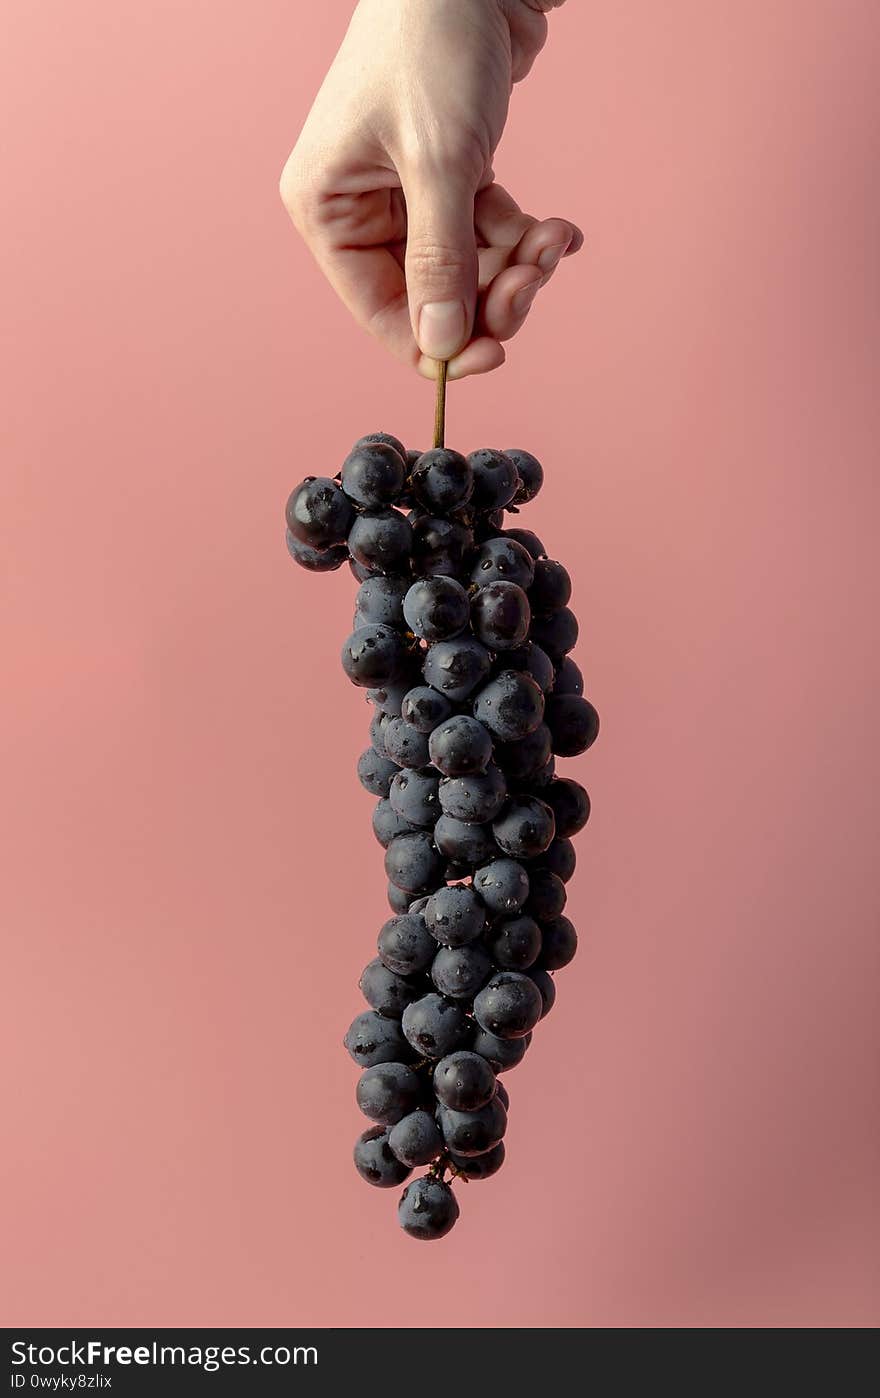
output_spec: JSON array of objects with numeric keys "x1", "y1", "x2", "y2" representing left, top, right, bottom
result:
[{"x1": 281, "y1": 0, "x2": 583, "y2": 379}]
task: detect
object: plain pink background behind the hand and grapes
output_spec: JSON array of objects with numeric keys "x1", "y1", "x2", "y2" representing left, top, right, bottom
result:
[{"x1": 0, "y1": 0, "x2": 880, "y2": 1327}]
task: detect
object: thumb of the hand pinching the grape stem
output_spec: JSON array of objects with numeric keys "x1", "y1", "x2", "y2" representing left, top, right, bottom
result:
[{"x1": 402, "y1": 168, "x2": 478, "y2": 359}]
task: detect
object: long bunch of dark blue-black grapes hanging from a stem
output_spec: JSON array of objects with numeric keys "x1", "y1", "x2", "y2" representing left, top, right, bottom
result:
[{"x1": 287, "y1": 399, "x2": 599, "y2": 1239}]
